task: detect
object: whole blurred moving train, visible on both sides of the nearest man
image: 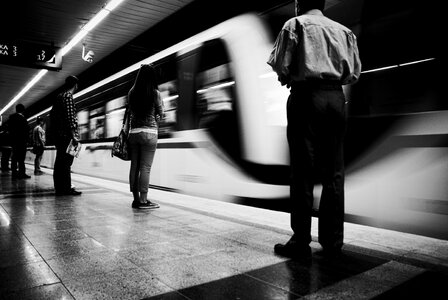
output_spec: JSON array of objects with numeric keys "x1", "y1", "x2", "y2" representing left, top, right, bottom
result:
[{"x1": 22, "y1": 0, "x2": 448, "y2": 239}]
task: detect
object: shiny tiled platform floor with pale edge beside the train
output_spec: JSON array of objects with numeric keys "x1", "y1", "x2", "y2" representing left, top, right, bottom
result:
[{"x1": 0, "y1": 169, "x2": 448, "y2": 300}]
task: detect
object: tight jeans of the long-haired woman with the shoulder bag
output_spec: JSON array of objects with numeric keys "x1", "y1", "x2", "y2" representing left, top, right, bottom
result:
[{"x1": 128, "y1": 132, "x2": 157, "y2": 193}]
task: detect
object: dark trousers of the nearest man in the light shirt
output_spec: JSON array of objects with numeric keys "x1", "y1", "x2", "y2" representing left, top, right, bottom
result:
[{"x1": 287, "y1": 84, "x2": 347, "y2": 250}]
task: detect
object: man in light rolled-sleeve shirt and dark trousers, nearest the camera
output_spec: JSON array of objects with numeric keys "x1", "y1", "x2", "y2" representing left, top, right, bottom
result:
[{"x1": 268, "y1": 0, "x2": 361, "y2": 260}]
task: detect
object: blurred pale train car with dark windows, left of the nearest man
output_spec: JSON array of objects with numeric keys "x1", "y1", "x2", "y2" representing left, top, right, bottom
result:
[{"x1": 29, "y1": 14, "x2": 289, "y2": 200}]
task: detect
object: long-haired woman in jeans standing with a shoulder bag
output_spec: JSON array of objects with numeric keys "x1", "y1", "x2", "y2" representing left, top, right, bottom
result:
[{"x1": 128, "y1": 65, "x2": 164, "y2": 209}]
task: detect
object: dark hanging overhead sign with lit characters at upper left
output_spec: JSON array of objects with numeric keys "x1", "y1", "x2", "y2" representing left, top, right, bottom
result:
[{"x1": 0, "y1": 40, "x2": 62, "y2": 71}]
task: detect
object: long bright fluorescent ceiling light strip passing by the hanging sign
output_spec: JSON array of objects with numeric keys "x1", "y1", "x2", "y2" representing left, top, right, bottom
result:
[{"x1": 0, "y1": 0, "x2": 124, "y2": 118}]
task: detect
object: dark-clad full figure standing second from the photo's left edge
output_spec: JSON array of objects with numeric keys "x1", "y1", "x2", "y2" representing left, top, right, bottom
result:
[{"x1": 8, "y1": 104, "x2": 31, "y2": 179}]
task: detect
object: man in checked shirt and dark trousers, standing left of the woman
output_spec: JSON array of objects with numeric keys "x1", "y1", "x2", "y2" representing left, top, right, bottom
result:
[{"x1": 50, "y1": 75, "x2": 81, "y2": 196}]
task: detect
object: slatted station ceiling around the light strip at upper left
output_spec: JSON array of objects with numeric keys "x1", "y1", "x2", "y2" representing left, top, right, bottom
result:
[{"x1": 0, "y1": 0, "x2": 194, "y2": 121}]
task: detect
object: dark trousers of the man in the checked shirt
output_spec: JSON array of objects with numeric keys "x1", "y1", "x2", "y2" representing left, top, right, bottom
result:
[{"x1": 53, "y1": 138, "x2": 74, "y2": 193}]
